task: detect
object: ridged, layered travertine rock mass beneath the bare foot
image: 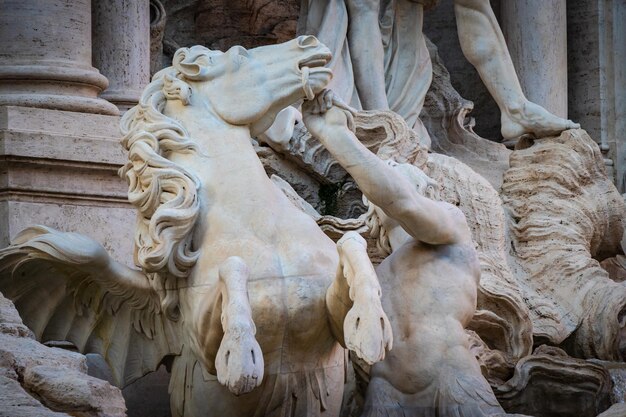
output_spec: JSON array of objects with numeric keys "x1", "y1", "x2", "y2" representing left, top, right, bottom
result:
[{"x1": 502, "y1": 130, "x2": 626, "y2": 360}]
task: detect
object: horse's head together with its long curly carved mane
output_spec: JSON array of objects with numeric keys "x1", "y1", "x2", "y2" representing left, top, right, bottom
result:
[{"x1": 120, "y1": 36, "x2": 332, "y2": 294}]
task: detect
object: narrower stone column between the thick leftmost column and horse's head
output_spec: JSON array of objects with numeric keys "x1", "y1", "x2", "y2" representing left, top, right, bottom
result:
[{"x1": 93, "y1": 0, "x2": 150, "y2": 111}]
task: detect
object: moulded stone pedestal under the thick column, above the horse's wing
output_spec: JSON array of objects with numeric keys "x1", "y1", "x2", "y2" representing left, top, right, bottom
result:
[{"x1": 0, "y1": 106, "x2": 135, "y2": 266}]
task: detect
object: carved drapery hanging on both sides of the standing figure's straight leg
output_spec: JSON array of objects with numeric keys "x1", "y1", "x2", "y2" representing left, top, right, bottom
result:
[{"x1": 298, "y1": 0, "x2": 436, "y2": 133}]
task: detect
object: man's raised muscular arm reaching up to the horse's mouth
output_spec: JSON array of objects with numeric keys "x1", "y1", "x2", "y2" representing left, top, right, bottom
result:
[{"x1": 303, "y1": 91, "x2": 465, "y2": 244}]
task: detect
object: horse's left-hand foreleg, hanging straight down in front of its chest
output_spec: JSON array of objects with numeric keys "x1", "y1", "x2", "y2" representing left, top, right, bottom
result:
[{"x1": 215, "y1": 256, "x2": 264, "y2": 395}]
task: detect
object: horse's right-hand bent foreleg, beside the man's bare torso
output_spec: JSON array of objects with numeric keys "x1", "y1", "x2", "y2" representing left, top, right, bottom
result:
[{"x1": 326, "y1": 232, "x2": 393, "y2": 365}]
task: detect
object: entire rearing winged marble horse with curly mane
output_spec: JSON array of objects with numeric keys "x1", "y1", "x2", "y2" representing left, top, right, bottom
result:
[{"x1": 0, "y1": 36, "x2": 392, "y2": 417}]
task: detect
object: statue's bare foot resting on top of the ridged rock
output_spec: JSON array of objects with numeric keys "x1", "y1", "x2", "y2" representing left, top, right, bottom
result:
[{"x1": 501, "y1": 101, "x2": 580, "y2": 140}]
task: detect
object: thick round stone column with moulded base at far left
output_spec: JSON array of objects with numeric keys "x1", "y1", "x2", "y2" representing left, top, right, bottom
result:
[{"x1": 0, "y1": 0, "x2": 117, "y2": 114}]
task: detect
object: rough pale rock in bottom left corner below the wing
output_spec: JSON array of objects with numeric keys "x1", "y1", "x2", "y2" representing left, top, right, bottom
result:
[{"x1": 0, "y1": 293, "x2": 126, "y2": 417}]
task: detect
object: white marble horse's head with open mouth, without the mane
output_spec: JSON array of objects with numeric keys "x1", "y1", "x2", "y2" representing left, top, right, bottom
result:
[{"x1": 166, "y1": 36, "x2": 332, "y2": 135}]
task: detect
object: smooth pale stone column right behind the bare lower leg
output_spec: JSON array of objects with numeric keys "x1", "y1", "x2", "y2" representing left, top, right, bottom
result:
[{"x1": 501, "y1": 0, "x2": 567, "y2": 117}]
